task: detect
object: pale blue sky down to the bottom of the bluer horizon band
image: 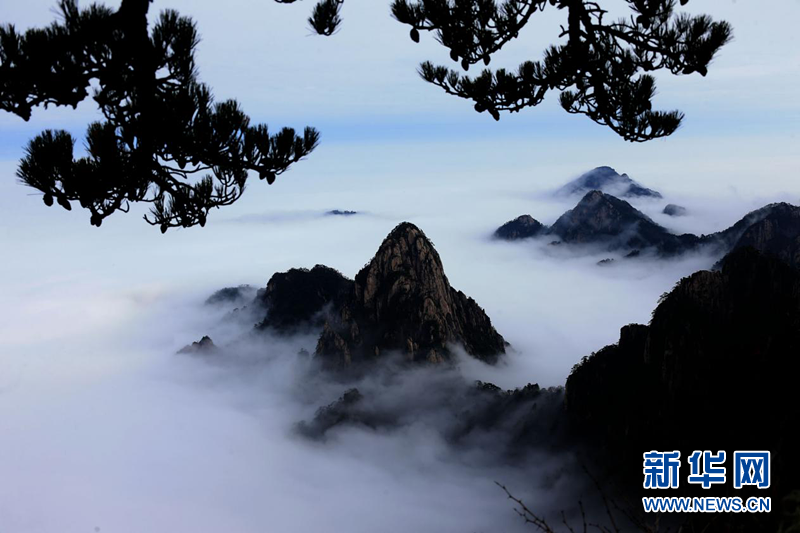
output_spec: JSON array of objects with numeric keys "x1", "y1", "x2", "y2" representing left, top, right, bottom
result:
[{"x1": 0, "y1": 0, "x2": 800, "y2": 145}]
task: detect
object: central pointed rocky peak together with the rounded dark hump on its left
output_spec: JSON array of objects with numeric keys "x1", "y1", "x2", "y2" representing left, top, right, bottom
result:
[{"x1": 258, "y1": 222, "x2": 506, "y2": 368}]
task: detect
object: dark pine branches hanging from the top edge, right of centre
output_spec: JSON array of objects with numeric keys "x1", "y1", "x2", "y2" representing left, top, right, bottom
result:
[{"x1": 276, "y1": 0, "x2": 732, "y2": 142}]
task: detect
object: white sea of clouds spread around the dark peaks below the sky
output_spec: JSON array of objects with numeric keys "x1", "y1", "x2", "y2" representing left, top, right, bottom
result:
[{"x1": 0, "y1": 142, "x2": 792, "y2": 532}]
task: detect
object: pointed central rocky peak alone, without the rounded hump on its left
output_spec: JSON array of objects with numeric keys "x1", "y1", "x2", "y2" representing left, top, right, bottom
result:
[{"x1": 317, "y1": 222, "x2": 506, "y2": 366}]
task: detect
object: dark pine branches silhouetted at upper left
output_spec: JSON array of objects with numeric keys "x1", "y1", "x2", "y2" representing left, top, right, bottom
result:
[{"x1": 0, "y1": 0, "x2": 319, "y2": 232}]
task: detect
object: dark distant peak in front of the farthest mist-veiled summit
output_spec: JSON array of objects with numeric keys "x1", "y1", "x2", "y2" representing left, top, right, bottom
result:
[{"x1": 548, "y1": 191, "x2": 699, "y2": 254}]
